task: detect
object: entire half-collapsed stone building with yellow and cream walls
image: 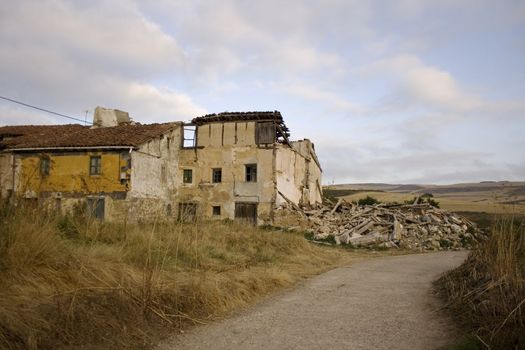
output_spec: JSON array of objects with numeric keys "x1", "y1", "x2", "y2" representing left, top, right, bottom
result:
[{"x1": 0, "y1": 108, "x2": 322, "y2": 224}]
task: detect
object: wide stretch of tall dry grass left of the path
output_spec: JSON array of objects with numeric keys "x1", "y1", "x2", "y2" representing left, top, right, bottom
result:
[{"x1": 0, "y1": 208, "x2": 343, "y2": 349}]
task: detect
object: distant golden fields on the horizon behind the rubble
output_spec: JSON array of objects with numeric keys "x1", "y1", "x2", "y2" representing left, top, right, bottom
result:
[{"x1": 324, "y1": 181, "x2": 525, "y2": 214}]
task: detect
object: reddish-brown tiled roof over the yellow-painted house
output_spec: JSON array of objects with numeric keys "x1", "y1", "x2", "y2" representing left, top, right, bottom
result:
[{"x1": 0, "y1": 123, "x2": 178, "y2": 149}]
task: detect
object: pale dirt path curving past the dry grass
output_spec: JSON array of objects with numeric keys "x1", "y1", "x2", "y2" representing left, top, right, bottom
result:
[{"x1": 159, "y1": 252, "x2": 467, "y2": 350}]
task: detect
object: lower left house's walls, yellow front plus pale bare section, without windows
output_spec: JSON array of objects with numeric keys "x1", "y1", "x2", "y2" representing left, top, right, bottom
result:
[{"x1": 1, "y1": 124, "x2": 181, "y2": 221}]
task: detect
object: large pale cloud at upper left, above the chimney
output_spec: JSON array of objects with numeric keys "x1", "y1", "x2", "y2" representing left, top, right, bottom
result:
[{"x1": 0, "y1": 1, "x2": 206, "y2": 123}]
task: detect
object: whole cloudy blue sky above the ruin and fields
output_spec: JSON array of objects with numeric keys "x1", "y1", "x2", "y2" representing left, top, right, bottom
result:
[{"x1": 0, "y1": 0, "x2": 525, "y2": 184}]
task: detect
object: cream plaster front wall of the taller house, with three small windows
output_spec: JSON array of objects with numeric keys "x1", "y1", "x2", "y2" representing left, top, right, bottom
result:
[{"x1": 176, "y1": 122, "x2": 275, "y2": 223}]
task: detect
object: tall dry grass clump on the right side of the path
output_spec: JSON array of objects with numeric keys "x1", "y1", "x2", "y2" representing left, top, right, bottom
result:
[{"x1": 437, "y1": 217, "x2": 525, "y2": 349}]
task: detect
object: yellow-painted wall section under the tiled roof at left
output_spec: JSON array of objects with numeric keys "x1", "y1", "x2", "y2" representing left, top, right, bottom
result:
[{"x1": 17, "y1": 151, "x2": 129, "y2": 196}]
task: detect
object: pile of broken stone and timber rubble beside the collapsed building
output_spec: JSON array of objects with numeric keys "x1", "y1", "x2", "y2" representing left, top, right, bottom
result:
[{"x1": 284, "y1": 200, "x2": 481, "y2": 250}]
